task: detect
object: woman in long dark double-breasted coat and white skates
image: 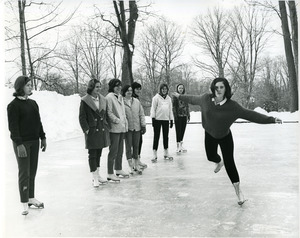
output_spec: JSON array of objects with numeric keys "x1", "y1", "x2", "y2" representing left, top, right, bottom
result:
[{"x1": 79, "y1": 79, "x2": 110, "y2": 187}]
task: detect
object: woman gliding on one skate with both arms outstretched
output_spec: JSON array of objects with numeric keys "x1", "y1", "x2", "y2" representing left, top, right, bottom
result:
[{"x1": 173, "y1": 78, "x2": 282, "y2": 205}]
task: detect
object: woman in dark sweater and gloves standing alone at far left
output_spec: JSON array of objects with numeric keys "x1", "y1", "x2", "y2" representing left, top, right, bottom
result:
[{"x1": 7, "y1": 76, "x2": 47, "y2": 215}]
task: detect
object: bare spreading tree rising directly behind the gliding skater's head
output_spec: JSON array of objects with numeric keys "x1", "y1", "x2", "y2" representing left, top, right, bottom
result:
[{"x1": 192, "y1": 8, "x2": 234, "y2": 77}]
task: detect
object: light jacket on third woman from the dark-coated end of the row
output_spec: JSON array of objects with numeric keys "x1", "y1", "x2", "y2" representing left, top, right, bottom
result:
[{"x1": 124, "y1": 97, "x2": 146, "y2": 131}]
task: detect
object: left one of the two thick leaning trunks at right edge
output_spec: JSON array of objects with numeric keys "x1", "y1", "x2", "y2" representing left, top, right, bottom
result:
[{"x1": 279, "y1": 1, "x2": 298, "y2": 112}]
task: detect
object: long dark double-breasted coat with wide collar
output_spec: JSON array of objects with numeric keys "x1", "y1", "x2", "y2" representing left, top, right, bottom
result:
[{"x1": 79, "y1": 94, "x2": 110, "y2": 149}]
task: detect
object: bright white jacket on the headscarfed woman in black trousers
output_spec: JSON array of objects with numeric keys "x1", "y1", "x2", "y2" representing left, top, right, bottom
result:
[{"x1": 150, "y1": 93, "x2": 174, "y2": 121}]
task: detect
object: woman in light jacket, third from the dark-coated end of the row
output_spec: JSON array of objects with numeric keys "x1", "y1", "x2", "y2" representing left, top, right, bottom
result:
[{"x1": 122, "y1": 85, "x2": 146, "y2": 174}]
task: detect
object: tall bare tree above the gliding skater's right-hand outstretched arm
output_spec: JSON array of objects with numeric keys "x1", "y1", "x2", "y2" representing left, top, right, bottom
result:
[{"x1": 229, "y1": 6, "x2": 268, "y2": 107}]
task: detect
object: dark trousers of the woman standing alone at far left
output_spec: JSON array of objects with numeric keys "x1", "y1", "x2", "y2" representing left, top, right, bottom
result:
[{"x1": 13, "y1": 140, "x2": 40, "y2": 202}]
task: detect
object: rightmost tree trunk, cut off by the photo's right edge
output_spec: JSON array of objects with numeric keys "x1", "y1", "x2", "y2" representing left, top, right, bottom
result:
[{"x1": 288, "y1": 1, "x2": 298, "y2": 79}]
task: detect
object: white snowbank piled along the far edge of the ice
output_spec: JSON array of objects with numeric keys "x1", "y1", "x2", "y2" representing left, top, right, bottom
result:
[{"x1": 4, "y1": 88, "x2": 299, "y2": 141}]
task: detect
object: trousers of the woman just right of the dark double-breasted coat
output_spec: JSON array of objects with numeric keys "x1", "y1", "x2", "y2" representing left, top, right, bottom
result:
[{"x1": 107, "y1": 133, "x2": 124, "y2": 174}]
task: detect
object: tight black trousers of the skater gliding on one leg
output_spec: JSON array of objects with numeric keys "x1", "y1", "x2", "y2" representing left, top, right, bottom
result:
[{"x1": 205, "y1": 132, "x2": 240, "y2": 183}]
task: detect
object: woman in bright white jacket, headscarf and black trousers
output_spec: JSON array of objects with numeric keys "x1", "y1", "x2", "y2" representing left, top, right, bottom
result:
[{"x1": 150, "y1": 83, "x2": 174, "y2": 163}]
